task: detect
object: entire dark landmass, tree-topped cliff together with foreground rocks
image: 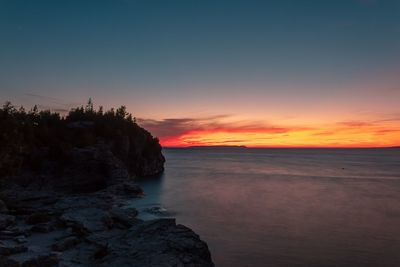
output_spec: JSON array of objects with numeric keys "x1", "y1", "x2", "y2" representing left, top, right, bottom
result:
[{"x1": 0, "y1": 104, "x2": 214, "y2": 267}]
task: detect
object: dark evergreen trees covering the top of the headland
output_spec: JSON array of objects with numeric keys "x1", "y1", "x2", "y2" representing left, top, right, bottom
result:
[{"x1": 0, "y1": 99, "x2": 161, "y2": 179}]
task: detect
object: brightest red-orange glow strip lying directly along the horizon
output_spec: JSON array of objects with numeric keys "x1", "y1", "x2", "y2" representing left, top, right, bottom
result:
[{"x1": 160, "y1": 123, "x2": 400, "y2": 148}]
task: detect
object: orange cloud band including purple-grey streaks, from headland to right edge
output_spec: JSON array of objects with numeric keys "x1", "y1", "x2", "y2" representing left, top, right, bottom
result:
[{"x1": 139, "y1": 115, "x2": 400, "y2": 147}]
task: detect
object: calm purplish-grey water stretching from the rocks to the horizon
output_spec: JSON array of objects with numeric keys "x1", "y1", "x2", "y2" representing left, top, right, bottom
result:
[{"x1": 134, "y1": 148, "x2": 400, "y2": 267}]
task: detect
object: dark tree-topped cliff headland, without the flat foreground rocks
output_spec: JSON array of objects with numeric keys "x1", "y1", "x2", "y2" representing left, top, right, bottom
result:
[{"x1": 0, "y1": 100, "x2": 165, "y2": 191}]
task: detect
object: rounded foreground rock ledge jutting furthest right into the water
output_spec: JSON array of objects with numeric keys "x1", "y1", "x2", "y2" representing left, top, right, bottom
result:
[{"x1": 96, "y1": 219, "x2": 214, "y2": 267}]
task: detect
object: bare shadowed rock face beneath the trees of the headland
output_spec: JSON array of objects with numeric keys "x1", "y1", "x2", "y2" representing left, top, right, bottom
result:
[{"x1": 11, "y1": 143, "x2": 165, "y2": 195}]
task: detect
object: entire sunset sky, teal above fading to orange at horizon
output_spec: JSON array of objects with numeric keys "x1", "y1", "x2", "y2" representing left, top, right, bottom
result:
[{"x1": 0, "y1": 0, "x2": 400, "y2": 147}]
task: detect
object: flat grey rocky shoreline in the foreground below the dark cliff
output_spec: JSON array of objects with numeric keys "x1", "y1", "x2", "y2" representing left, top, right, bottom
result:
[{"x1": 0, "y1": 181, "x2": 214, "y2": 267}]
